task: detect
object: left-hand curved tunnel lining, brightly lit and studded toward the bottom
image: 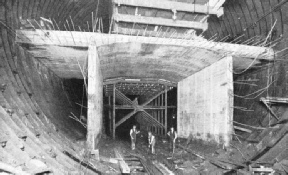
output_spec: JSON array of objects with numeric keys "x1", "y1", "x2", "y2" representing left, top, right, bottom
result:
[{"x1": 0, "y1": 0, "x2": 107, "y2": 174}]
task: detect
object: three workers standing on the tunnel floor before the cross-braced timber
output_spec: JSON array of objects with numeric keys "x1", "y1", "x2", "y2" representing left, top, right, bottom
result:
[{"x1": 130, "y1": 125, "x2": 177, "y2": 154}]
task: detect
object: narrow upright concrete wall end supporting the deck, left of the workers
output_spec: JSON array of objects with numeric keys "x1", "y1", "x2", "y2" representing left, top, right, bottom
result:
[{"x1": 87, "y1": 46, "x2": 103, "y2": 150}]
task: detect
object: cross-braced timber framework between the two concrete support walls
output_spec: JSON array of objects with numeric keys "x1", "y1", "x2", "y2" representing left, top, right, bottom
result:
[{"x1": 104, "y1": 78, "x2": 176, "y2": 138}]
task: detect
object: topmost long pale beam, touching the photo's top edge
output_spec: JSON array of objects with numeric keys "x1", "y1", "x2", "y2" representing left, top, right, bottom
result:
[{"x1": 114, "y1": 0, "x2": 224, "y2": 17}]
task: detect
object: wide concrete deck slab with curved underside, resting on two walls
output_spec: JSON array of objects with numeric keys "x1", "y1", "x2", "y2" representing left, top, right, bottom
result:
[{"x1": 16, "y1": 30, "x2": 274, "y2": 82}]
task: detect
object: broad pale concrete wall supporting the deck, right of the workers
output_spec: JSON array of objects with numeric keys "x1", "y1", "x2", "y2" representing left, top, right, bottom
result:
[{"x1": 177, "y1": 57, "x2": 233, "y2": 145}]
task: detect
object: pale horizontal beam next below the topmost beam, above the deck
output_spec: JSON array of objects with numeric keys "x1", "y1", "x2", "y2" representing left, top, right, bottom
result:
[{"x1": 113, "y1": 14, "x2": 208, "y2": 31}]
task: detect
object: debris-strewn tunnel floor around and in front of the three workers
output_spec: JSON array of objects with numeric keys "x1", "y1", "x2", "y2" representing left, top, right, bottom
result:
[{"x1": 95, "y1": 133, "x2": 248, "y2": 175}]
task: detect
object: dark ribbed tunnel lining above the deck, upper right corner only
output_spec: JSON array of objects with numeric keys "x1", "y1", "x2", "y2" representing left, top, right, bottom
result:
[{"x1": 205, "y1": 0, "x2": 288, "y2": 48}]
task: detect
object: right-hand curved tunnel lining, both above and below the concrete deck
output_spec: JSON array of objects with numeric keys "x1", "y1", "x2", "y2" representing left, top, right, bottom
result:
[{"x1": 205, "y1": 0, "x2": 288, "y2": 126}]
